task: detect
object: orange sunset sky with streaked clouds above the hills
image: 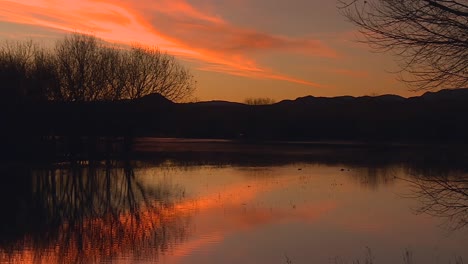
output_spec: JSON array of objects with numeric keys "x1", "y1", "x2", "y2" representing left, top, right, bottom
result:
[{"x1": 0, "y1": 0, "x2": 419, "y2": 102}]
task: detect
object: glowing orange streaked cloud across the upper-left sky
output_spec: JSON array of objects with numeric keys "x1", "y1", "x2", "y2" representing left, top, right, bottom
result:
[{"x1": 0, "y1": 0, "x2": 337, "y2": 87}]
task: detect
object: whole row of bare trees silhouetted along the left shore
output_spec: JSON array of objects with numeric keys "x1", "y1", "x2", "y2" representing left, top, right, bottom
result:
[{"x1": 0, "y1": 34, "x2": 195, "y2": 103}]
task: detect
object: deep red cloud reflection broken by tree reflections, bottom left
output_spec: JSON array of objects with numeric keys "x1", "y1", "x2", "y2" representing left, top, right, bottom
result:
[{"x1": 0, "y1": 204, "x2": 188, "y2": 264}]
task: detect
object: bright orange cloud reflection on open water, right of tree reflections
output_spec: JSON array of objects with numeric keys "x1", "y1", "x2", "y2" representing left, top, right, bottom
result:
[{"x1": 168, "y1": 178, "x2": 337, "y2": 263}]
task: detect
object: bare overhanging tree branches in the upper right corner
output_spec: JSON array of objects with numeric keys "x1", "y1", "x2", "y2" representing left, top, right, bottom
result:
[{"x1": 338, "y1": 0, "x2": 468, "y2": 90}]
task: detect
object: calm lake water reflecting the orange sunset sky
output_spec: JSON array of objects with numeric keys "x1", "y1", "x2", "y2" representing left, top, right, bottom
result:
[{"x1": 0, "y1": 139, "x2": 468, "y2": 264}]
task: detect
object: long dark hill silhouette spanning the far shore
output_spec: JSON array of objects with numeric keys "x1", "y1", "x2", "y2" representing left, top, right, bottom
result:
[{"x1": 0, "y1": 89, "x2": 468, "y2": 151}]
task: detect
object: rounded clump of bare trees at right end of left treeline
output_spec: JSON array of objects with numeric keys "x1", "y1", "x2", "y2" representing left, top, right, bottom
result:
[{"x1": 56, "y1": 34, "x2": 195, "y2": 101}]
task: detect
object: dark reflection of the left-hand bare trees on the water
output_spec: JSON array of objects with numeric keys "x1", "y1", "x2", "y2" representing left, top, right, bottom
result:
[{"x1": 0, "y1": 161, "x2": 188, "y2": 263}]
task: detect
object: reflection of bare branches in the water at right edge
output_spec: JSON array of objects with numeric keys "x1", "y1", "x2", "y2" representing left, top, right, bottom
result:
[{"x1": 408, "y1": 173, "x2": 468, "y2": 230}]
